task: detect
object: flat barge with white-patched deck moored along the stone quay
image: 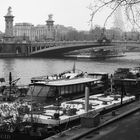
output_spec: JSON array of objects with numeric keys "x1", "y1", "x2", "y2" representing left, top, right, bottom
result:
[{"x1": 25, "y1": 93, "x2": 135, "y2": 129}]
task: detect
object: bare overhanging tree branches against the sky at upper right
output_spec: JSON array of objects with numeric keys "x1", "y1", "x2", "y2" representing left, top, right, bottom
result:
[{"x1": 89, "y1": 0, "x2": 140, "y2": 28}]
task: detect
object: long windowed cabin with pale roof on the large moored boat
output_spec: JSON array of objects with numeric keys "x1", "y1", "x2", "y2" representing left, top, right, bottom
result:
[{"x1": 27, "y1": 77, "x2": 101, "y2": 99}]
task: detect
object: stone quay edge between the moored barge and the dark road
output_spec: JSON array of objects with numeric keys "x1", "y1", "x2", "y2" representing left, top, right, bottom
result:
[{"x1": 45, "y1": 101, "x2": 140, "y2": 140}]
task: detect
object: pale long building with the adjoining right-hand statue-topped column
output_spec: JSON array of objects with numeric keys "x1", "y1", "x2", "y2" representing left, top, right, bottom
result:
[{"x1": 13, "y1": 15, "x2": 55, "y2": 41}]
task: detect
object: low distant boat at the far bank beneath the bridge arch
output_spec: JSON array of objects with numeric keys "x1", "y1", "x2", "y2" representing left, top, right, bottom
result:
[{"x1": 64, "y1": 49, "x2": 125, "y2": 59}]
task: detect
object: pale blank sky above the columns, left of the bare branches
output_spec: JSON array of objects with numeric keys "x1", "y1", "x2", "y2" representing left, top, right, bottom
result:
[{"x1": 0, "y1": 0, "x2": 116, "y2": 32}]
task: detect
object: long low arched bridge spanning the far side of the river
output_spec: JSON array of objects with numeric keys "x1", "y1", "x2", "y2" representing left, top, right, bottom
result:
[{"x1": 29, "y1": 41, "x2": 140, "y2": 57}]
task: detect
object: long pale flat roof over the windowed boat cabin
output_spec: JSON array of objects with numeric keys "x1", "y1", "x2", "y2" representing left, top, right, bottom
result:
[{"x1": 30, "y1": 77, "x2": 100, "y2": 86}]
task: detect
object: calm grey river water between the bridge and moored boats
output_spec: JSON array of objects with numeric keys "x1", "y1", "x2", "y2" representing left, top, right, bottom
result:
[{"x1": 0, "y1": 52, "x2": 140, "y2": 85}]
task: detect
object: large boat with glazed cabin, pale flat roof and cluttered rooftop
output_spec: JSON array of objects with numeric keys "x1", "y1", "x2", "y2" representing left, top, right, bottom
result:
[{"x1": 27, "y1": 69, "x2": 108, "y2": 101}]
